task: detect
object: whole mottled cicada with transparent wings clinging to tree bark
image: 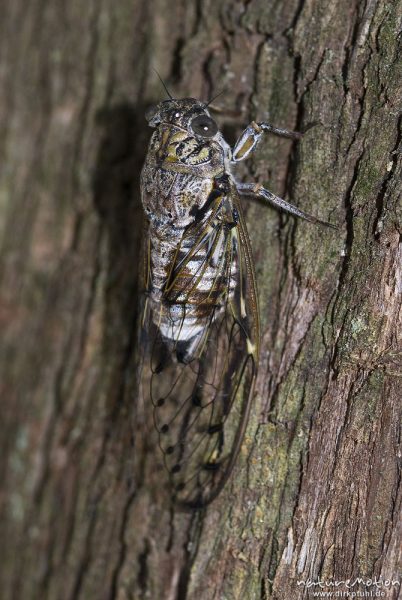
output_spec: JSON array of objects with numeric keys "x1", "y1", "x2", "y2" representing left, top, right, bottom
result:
[{"x1": 141, "y1": 84, "x2": 333, "y2": 508}]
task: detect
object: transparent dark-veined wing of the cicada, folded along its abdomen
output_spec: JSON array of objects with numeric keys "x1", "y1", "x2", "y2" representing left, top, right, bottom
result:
[{"x1": 143, "y1": 193, "x2": 259, "y2": 508}]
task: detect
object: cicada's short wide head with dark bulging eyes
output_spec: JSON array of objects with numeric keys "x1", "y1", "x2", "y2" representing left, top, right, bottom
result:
[{"x1": 145, "y1": 98, "x2": 218, "y2": 138}]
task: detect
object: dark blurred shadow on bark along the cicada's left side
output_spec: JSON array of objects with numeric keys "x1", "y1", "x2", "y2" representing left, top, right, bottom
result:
[{"x1": 93, "y1": 104, "x2": 150, "y2": 421}]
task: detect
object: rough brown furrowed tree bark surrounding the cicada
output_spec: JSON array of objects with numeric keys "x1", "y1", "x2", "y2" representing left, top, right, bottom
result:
[{"x1": 0, "y1": 0, "x2": 402, "y2": 600}]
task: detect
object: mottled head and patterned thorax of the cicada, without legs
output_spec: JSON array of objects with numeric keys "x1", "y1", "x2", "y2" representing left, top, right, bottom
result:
[{"x1": 141, "y1": 98, "x2": 230, "y2": 228}]
